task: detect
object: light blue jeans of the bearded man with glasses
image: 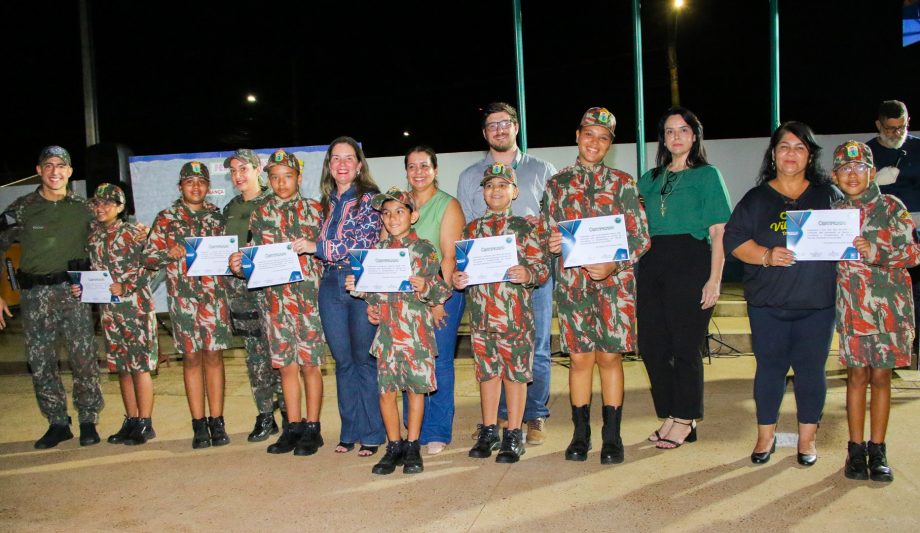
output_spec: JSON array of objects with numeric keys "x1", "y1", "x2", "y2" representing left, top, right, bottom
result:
[{"x1": 498, "y1": 275, "x2": 553, "y2": 421}]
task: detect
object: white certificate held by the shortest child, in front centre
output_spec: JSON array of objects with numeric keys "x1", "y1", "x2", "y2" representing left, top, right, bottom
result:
[{"x1": 348, "y1": 248, "x2": 412, "y2": 292}]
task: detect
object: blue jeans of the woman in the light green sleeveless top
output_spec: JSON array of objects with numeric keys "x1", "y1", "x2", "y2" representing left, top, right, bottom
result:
[{"x1": 403, "y1": 291, "x2": 466, "y2": 444}]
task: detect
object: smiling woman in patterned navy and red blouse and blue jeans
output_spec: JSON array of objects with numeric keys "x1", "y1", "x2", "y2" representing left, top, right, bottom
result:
[{"x1": 316, "y1": 137, "x2": 386, "y2": 456}]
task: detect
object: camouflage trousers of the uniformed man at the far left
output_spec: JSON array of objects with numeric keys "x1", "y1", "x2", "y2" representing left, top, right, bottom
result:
[{"x1": 21, "y1": 283, "x2": 105, "y2": 424}]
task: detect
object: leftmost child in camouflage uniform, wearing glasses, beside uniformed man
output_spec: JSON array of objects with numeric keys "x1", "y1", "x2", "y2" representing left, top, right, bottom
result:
[{"x1": 72, "y1": 183, "x2": 159, "y2": 445}]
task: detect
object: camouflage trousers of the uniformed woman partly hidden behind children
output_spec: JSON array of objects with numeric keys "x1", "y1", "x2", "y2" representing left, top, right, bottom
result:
[{"x1": 228, "y1": 278, "x2": 284, "y2": 414}]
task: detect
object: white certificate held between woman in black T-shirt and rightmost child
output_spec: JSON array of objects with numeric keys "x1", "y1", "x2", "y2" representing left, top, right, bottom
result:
[{"x1": 786, "y1": 209, "x2": 859, "y2": 261}]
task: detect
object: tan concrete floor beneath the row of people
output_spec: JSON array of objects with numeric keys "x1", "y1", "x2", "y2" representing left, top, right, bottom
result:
[{"x1": 0, "y1": 351, "x2": 920, "y2": 532}]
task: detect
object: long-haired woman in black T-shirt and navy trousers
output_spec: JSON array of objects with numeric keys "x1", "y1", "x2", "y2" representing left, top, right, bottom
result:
[{"x1": 724, "y1": 122, "x2": 842, "y2": 466}]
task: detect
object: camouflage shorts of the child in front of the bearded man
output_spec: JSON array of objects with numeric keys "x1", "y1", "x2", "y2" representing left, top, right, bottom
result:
[{"x1": 472, "y1": 329, "x2": 534, "y2": 383}]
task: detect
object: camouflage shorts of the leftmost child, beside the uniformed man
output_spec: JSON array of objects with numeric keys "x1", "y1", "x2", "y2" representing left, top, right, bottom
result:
[{"x1": 99, "y1": 304, "x2": 160, "y2": 374}]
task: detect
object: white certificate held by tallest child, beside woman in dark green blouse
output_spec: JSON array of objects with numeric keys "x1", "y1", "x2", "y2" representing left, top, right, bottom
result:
[{"x1": 559, "y1": 215, "x2": 629, "y2": 268}]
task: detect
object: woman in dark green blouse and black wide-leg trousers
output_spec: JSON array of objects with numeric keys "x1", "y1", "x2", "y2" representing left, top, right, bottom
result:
[{"x1": 636, "y1": 107, "x2": 731, "y2": 449}]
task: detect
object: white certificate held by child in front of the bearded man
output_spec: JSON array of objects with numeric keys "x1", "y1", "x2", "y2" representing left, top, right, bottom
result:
[{"x1": 454, "y1": 235, "x2": 518, "y2": 285}]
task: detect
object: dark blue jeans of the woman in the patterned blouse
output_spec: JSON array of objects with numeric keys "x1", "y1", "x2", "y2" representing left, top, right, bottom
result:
[{"x1": 319, "y1": 269, "x2": 386, "y2": 446}]
